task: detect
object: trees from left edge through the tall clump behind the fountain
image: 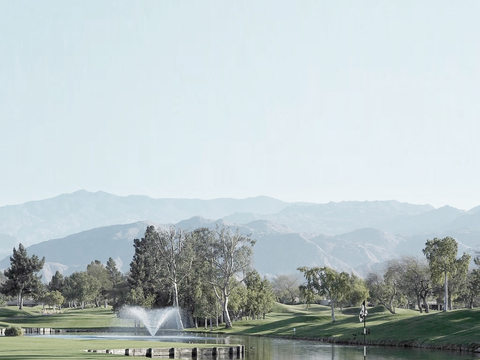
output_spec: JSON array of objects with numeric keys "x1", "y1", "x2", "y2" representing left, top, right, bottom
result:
[{"x1": 0, "y1": 226, "x2": 275, "y2": 327}]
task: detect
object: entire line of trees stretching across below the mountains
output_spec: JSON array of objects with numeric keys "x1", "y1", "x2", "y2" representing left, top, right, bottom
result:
[{"x1": 0, "y1": 226, "x2": 480, "y2": 327}]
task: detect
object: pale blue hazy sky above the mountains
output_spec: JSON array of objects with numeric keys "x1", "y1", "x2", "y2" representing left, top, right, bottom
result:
[{"x1": 0, "y1": 0, "x2": 480, "y2": 210}]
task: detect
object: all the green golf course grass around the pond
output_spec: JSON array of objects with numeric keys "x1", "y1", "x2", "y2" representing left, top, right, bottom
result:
[{"x1": 0, "y1": 304, "x2": 480, "y2": 360}]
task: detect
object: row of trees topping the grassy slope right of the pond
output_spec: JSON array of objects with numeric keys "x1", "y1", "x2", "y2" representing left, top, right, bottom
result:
[{"x1": 298, "y1": 236, "x2": 480, "y2": 322}]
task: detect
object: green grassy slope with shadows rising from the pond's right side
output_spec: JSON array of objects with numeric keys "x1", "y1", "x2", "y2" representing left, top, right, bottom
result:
[{"x1": 193, "y1": 305, "x2": 480, "y2": 351}]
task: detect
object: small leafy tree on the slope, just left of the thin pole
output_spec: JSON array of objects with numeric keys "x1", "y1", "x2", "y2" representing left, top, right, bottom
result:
[{"x1": 298, "y1": 266, "x2": 350, "y2": 322}]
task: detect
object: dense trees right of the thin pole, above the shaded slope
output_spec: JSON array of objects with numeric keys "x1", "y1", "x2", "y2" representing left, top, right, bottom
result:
[{"x1": 366, "y1": 237, "x2": 474, "y2": 313}]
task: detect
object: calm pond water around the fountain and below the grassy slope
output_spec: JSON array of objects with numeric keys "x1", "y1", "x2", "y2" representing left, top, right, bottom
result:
[{"x1": 37, "y1": 332, "x2": 480, "y2": 360}]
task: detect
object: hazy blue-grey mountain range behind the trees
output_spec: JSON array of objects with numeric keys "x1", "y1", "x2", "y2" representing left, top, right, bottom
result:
[{"x1": 0, "y1": 190, "x2": 480, "y2": 280}]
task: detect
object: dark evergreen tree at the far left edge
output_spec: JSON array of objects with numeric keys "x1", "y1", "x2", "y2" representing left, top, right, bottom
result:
[{"x1": 0, "y1": 244, "x2": 45, "y2": 310}]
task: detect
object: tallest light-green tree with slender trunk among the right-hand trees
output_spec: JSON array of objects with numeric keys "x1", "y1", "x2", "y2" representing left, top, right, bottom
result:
[{"x1": 423, "y1": 236, "x2": 468, "y2": 311}]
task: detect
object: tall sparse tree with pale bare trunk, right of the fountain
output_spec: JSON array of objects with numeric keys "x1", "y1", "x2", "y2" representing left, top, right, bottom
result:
[{"x1": 194, "y1": 227, "x2": 255, "y2": 328}]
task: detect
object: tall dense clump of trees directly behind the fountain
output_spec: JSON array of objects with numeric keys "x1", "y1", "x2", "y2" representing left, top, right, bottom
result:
[{"x1": 122, "y1": 226, "x2": 262, "y2": 327}]
